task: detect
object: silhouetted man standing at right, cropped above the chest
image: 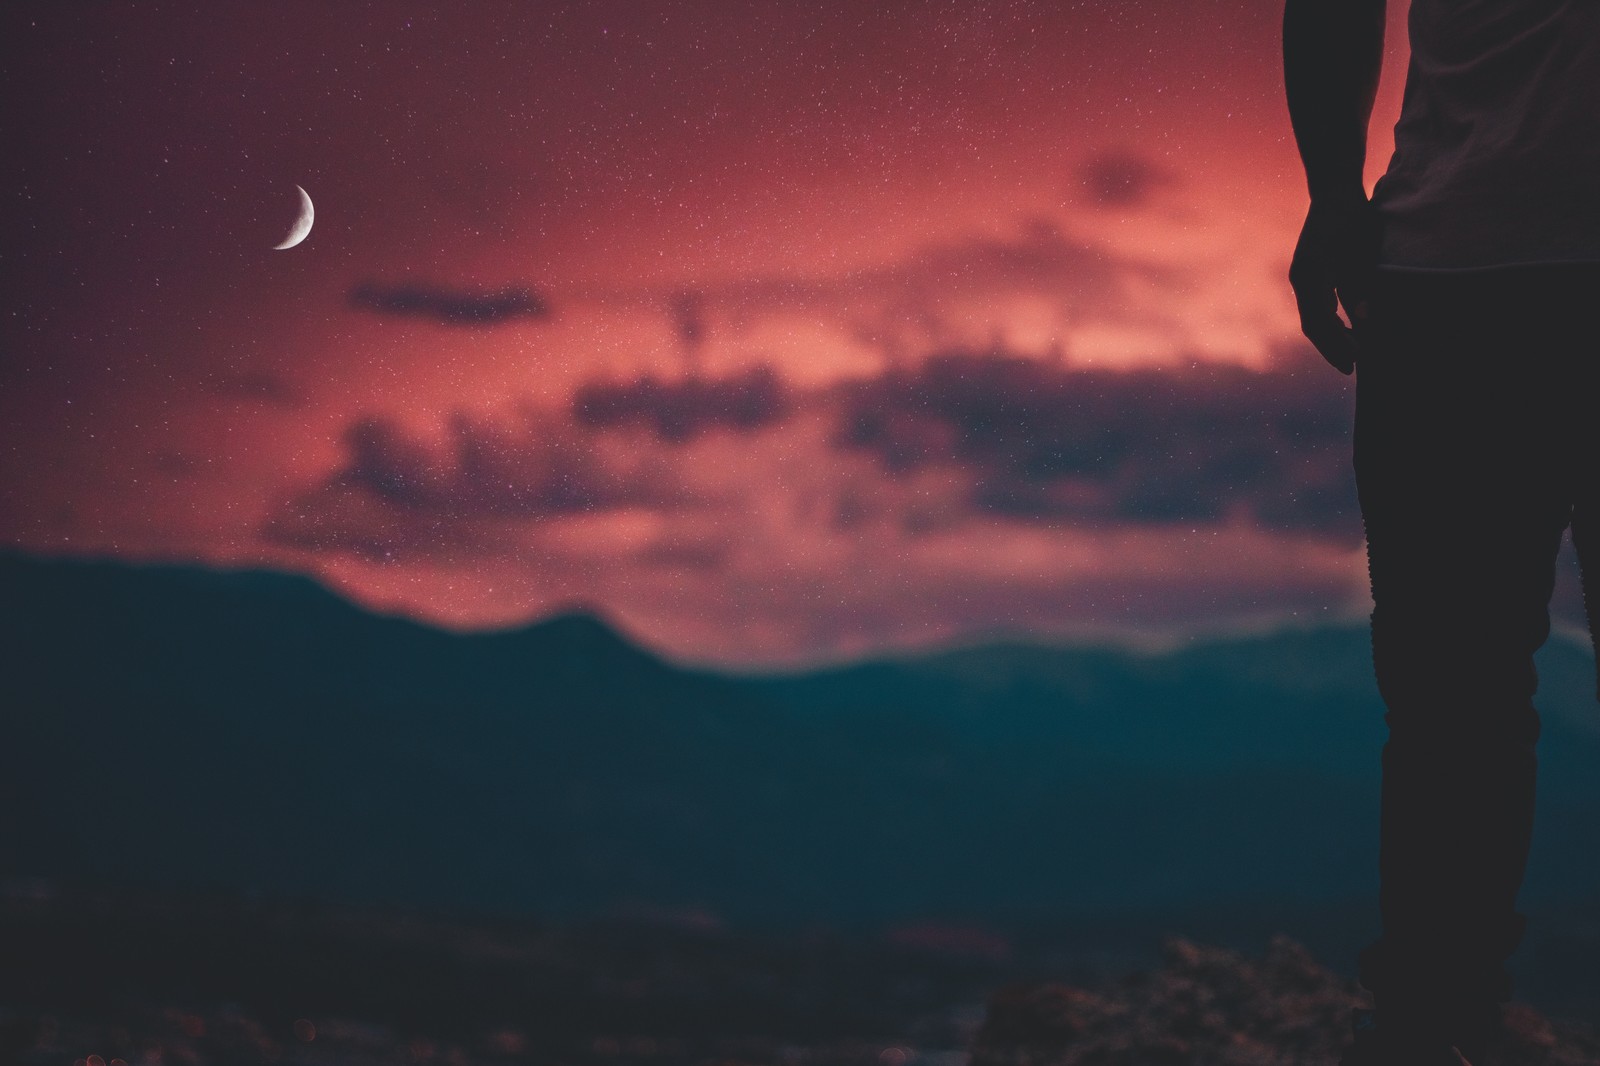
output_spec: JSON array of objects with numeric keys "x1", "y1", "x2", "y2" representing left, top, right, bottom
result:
[{"x1": 1283, "y1": 0, "x2": 1600, "y2": 1066}]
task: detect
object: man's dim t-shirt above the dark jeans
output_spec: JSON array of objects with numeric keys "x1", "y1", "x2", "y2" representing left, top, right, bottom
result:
[{"x1": 1373, "y1": 0, "x2": 1600, "y2": 269}]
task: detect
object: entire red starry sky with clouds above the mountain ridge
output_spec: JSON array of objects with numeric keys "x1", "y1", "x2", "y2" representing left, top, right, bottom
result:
[{"x1": 15, "y1": 0, "x2": 1561, "y2": 667}]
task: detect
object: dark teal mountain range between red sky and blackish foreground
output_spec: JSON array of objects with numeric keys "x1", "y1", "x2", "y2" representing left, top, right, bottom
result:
[{"x1": 9, "y1": 554, "x2": 1600, "y2": 925}]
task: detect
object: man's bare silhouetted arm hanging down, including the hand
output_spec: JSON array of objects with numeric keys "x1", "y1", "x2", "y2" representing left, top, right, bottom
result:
[{"x1": 1283, "y1": 0, "x2": 1387, "y2": 373}]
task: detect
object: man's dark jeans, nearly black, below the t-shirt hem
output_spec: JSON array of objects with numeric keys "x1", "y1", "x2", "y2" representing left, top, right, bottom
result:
[{"x1": 1355, "y1": 264, "x2": 1600, "y2": 1024}]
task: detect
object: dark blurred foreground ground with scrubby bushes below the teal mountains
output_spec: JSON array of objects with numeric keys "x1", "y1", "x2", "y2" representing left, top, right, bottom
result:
[{"x1": 0, "y1": 884, "x2": 1600, "y2": 1066}]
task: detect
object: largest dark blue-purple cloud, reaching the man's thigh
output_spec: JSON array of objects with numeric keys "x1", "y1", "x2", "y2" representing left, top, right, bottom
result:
[{"x1": 832, "y1": 351, "x2": 1360, "y2": 539}]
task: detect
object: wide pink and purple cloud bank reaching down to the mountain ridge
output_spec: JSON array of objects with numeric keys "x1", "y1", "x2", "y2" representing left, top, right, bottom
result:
[{"x1": 264, "y1": 349, "x2": 1365, "y2": 663}]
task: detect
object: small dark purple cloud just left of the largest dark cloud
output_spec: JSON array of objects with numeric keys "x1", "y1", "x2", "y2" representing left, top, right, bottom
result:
[{"x1": 573, "y1": 363, "x2": 792, "y2": 442}]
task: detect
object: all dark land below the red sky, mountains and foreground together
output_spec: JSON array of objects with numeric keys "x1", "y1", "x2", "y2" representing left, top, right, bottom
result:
[{"x1": 9, "y1": 554, "x2": 1600, "y2": 1066}]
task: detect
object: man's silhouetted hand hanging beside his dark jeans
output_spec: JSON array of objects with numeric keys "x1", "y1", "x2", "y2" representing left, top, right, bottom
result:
[{"x1": 1290, "y1": 194, "x2": 1381, "y2": 375}]
